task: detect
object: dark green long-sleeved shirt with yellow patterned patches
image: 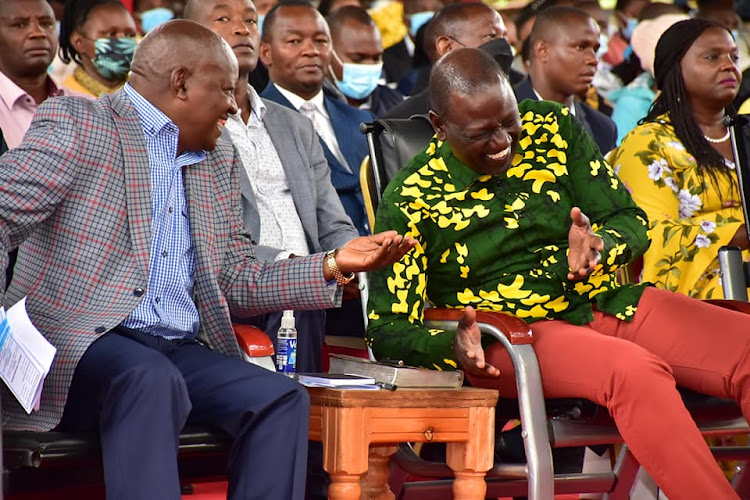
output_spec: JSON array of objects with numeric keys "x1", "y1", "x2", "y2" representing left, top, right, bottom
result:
[{"x1": 367, "y1": 100, "x2": 649, "y2": 369}]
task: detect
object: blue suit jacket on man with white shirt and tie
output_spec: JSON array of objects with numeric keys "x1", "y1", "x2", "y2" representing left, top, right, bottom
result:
[{"x1": 260, "y1": 82, "x2": 375, "y2": 235}]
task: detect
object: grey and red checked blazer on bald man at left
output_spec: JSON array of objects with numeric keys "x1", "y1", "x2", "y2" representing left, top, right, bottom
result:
[{"x1": 0, "y1": 91, "x2": 340, "y2": 430}]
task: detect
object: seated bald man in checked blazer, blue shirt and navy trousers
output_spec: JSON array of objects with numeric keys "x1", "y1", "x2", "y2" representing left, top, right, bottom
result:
[{"x1": 0, "y1": 21, "x2": 414, "y2": 500}]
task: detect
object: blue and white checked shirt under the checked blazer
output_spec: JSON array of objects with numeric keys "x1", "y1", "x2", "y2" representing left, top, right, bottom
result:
[{"x1": 122, "y1": 85, "x2": 206, "y2": 339}]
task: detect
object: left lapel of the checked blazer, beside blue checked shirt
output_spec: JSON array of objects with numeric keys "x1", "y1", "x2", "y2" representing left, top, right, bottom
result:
[{"x1": 110, "y1": 90, "x2": 153, "y2": 276}]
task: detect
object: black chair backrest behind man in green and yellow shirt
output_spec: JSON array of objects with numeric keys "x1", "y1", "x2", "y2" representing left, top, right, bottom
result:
[{"x1": 360, "y1": 115, "x2": 435, "y2": 222}]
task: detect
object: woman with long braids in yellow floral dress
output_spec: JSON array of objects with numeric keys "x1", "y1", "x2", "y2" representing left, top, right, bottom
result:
[{"x1": 609, "y1": 19, "x2": 749, "y2": 298}]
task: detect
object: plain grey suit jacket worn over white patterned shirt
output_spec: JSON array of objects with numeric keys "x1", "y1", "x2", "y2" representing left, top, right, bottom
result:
[{"x1": 223, "y1": 99, "x2": 359, "y2": 260}]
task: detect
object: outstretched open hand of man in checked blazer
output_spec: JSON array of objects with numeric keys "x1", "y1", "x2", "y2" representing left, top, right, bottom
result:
[{"x1": 332, "y1": 231, "x2": 417, "y2": 279}]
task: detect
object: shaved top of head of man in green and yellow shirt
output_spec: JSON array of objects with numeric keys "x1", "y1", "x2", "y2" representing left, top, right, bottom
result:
[{"x1": 429, "y1": 48, "x2": 512, "y2": 116}]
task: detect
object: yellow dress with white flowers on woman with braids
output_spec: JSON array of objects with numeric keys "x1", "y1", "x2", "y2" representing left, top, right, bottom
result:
[{"x1": 608, "y1": 115, "x2": 748, "y2": 299}]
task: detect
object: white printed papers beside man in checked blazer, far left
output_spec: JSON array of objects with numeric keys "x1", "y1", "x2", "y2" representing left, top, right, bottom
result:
[{"x1": 0, "y1": 297, "x2": 57, "y2": 413}]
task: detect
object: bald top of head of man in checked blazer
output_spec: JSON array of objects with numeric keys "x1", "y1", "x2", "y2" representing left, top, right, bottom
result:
[{"x1": 130, "y1": 20, "x2": 237, "y2": 92}]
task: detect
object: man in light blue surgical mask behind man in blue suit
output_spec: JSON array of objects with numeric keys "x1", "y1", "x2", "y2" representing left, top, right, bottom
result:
[{"x1": 324, "y1": 5, "x2": 404, "y2": 116}]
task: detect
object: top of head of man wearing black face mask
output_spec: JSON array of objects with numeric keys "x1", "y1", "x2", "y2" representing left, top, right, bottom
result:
[{"x1": 424, "y1": 2, "x2": 508, "y2": 61}]
